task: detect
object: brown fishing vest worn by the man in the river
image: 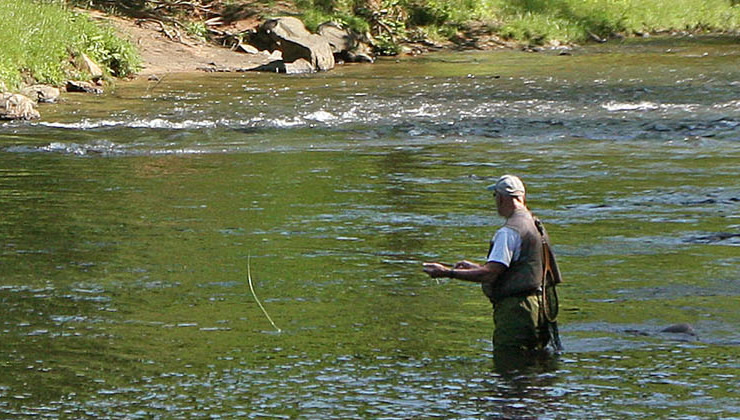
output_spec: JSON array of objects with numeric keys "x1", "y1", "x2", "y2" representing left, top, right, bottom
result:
[{"x1": 486, "y1": 209, "x2": 543, "y2": 302}]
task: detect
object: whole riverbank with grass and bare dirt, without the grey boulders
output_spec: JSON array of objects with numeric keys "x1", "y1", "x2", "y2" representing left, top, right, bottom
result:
[{"x1": 0, "y1": 0, "x2": 740, "y2": 121}]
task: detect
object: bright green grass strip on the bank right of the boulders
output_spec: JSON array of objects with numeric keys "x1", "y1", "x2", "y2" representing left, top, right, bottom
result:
[{"x1": 296, "y1": 0, "x2": 740, "y2": 49}]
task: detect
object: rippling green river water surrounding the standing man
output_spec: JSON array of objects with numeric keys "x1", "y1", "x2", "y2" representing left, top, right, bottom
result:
[{"x1": 0, "y1": 38, "x2": 740, "y2": 419}]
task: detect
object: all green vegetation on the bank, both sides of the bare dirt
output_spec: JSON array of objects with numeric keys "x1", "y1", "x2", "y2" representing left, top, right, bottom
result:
[{"x1": 0, "y1": 0, "x2": 740, "y2": 90}]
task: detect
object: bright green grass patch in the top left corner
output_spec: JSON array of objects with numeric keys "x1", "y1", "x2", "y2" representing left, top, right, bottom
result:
[{"x1": 0, "y1": 0, "x2": 139, "y2": 89}]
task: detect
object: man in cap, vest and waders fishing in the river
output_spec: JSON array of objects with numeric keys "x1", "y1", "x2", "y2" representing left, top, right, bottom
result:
[{"x1": 424, "y1": 175, "x2": 561, "y2": 353}]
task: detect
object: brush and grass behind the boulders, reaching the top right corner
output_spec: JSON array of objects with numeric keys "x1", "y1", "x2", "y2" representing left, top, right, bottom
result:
[{"x1": 69, "y1": 0, "x2": 740, "y2": 50}]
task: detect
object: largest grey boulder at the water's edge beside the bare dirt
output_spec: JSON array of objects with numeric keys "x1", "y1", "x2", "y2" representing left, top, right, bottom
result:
[{"x1": 259, "y1": 17, "x2": 334, "y2": 71}]
